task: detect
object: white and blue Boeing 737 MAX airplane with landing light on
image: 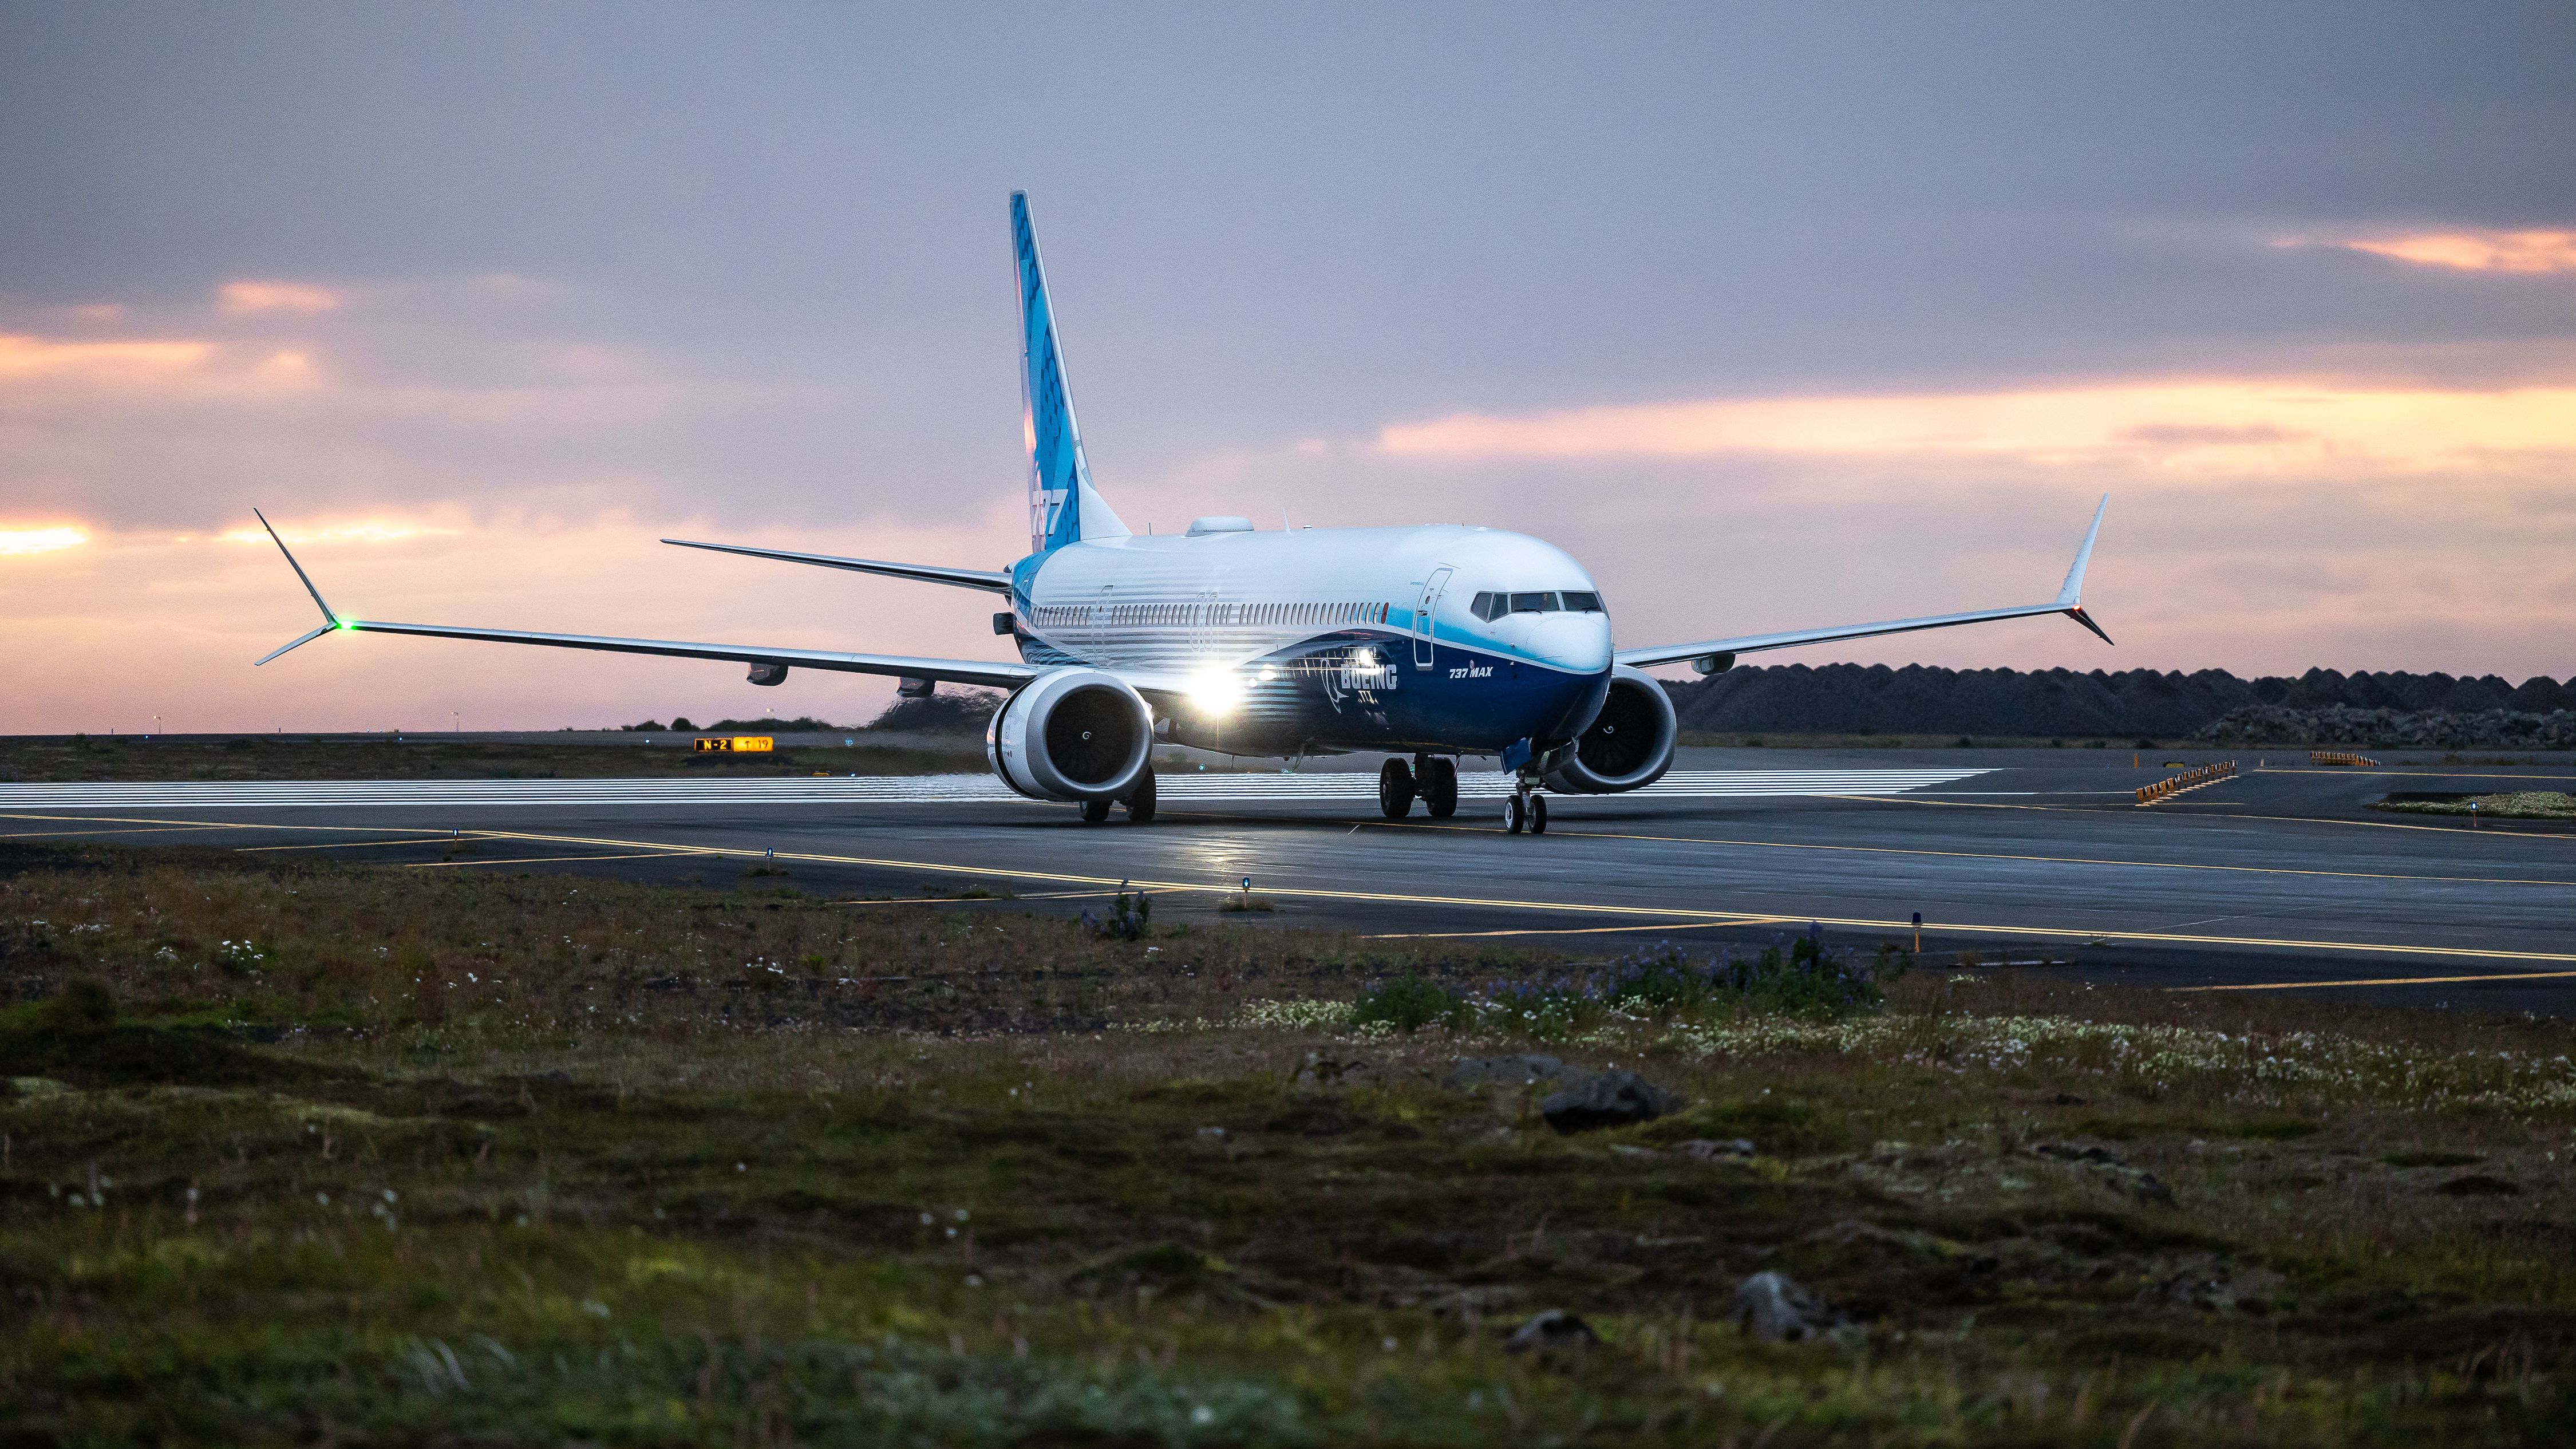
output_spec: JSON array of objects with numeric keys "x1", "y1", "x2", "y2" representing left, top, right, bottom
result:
[{"x1": 252, "y1": 191, "x2": 2110, "y2": 835}]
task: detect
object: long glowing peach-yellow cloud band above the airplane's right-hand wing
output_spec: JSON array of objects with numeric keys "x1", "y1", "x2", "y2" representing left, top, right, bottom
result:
[{"x1": 1376, "y1": 379, "x2": 2576, "y2": 477}]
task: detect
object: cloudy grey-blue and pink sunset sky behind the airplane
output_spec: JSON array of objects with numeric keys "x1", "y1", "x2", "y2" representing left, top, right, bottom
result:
[{"x1": 0, "y1": 0, "x2": 2576, "y2": 732}]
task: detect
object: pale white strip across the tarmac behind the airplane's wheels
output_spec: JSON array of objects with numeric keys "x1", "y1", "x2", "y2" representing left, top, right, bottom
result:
[{"x1": 0, "y1": 768, "x2": 1986, "y2": 810}]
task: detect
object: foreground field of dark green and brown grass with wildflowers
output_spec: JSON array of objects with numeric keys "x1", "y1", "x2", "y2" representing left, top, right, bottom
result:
[{"x1": 0, "y1": 848, "x2": 2576, "y2": 1449}]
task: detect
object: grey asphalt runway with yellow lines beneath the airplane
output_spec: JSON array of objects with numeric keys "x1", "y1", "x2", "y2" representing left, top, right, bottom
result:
[{"x1": 0, "y1": 751, "x2": 2576, "y2": 1010}]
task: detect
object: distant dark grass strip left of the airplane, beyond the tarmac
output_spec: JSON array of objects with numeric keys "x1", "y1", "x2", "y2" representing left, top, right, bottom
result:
[{"x1": 0, "y1": 735, "x2": 987, "y2": 784}]
